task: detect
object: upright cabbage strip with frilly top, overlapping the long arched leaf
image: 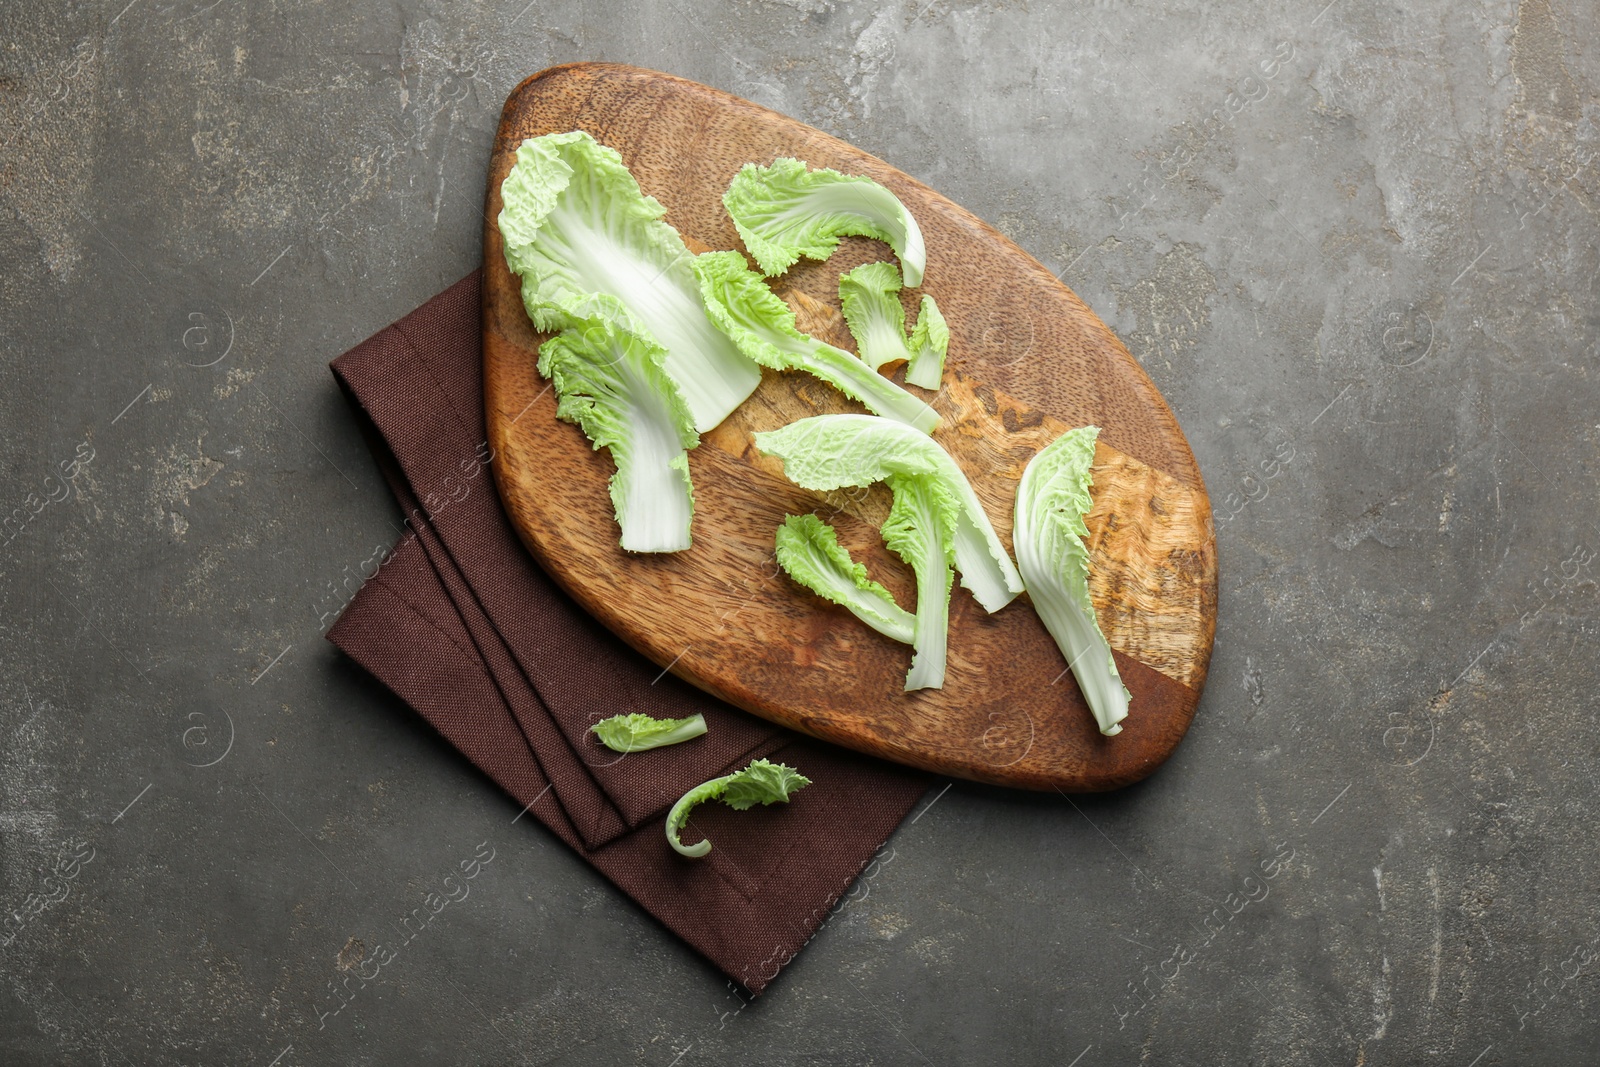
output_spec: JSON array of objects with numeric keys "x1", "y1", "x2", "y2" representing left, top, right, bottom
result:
[{"x1": 883, "y1": 474, "x2": 962, "y2": 693}]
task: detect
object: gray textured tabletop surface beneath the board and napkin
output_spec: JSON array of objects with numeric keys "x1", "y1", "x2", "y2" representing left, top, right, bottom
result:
[{"x1": 0, "y1": 0, "x2": 1600, "y2": 1067}]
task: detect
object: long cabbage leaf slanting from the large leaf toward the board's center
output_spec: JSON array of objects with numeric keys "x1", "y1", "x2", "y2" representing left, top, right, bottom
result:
[{"x1": 694, "y1": 251, "x2": 939, "y2": 434}]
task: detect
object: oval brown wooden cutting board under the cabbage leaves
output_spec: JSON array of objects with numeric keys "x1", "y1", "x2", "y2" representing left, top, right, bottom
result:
[{"x1": 483, "y1": 64, "x2": 1216, "y2": 792}]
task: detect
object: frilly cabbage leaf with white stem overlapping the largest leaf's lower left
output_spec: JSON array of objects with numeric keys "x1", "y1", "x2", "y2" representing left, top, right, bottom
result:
[{"x1": 539, "y1": 318, "x2": 699, "y2": 552}]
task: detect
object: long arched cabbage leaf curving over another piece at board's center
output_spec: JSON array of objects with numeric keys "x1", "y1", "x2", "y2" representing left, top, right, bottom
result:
[{"x1": 755, "y1": 414, "x2": 1022, "y2": 611}]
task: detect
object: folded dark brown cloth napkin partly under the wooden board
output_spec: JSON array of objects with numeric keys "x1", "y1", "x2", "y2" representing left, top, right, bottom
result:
[{"x1": 328, "y1": 272, "x2": 930, "y2": 993}]
